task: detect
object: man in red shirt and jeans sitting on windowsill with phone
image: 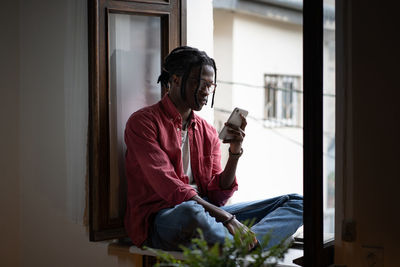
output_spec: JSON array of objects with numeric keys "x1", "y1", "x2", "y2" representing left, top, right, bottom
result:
[{"x1": 125, "y1": 46, "x2": 302, "y2": 250}]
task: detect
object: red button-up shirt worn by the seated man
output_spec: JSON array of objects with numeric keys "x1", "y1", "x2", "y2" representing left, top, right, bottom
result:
[{"x1": 125, "y1": 95, "x2": 238, "y2": 246}]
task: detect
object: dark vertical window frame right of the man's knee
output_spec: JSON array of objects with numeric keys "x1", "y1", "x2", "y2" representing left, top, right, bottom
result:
[{"x1": 301, "y1": 0, "x2": 334, "y2": 267}]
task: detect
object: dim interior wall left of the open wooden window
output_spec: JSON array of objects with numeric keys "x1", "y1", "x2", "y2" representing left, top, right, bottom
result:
[{"x1": 0, "y1": 0, "x2": 132, "y2": 267}]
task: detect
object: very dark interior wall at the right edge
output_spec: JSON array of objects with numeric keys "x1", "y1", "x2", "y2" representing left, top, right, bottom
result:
[{"x1": 336, "y1": 1, "x2": 400, "y2": 267}]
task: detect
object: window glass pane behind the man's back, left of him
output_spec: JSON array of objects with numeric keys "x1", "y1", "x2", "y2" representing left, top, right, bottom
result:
[{"x1": 108, "y1": 13, "x2": 161, "y2": 218}]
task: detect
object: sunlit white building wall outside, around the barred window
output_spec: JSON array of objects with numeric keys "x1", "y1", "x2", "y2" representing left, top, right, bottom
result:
[{"x1": 214, "y1": 9, "x2": 303, "y2": 203}]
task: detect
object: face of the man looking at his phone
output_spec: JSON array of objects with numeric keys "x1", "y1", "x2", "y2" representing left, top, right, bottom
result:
[{"x1": 186, "y1": 65, "x2": 214, "y2": 111}]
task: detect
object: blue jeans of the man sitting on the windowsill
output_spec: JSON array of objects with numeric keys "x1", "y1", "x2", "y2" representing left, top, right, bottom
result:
[{"x1": 146, "y1": 194, "x2": 303, "y2": 250}]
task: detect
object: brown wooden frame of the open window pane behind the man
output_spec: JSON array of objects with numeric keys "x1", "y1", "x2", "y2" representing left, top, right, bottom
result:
[{"x1": 88, "y1": 0, "x2": 186, "y2": 241}]
